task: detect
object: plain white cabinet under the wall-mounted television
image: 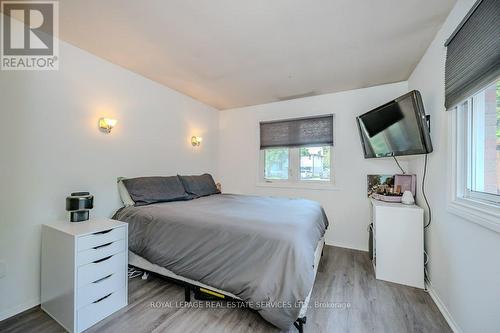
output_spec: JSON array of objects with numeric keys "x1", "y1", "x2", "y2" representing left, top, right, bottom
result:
[{"x1": 371, "y1": 199, "x2": 425, "y2": 289}]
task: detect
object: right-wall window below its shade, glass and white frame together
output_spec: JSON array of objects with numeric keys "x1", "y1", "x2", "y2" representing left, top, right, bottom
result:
[{"x1": 448, "y1": 80, "x2": 500, "y2": 232}]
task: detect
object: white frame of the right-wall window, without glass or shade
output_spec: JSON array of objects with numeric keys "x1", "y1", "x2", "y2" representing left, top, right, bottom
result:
[{"x1": 448, "y1": 81, "x2": 500, "y2": 232}]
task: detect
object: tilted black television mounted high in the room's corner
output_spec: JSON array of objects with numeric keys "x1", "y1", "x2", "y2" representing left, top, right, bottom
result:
[{"x1": 357, "y1": 90, "x2": 432, "y2": 158}]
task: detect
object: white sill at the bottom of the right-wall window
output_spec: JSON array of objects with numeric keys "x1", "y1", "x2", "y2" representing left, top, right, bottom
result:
[{"x1": 447, "y1": 198, "x2": 500, "y2": 233}]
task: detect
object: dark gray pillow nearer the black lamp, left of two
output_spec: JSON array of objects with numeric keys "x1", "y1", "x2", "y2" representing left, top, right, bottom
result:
[{"x1": 123, "y1": 176, "x2": 190, "y2": 206}]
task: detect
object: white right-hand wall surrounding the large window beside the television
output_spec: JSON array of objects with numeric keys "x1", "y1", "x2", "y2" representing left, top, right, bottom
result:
[{"x1": 408, "y1": 0, "x2": 500, "y2": 333}]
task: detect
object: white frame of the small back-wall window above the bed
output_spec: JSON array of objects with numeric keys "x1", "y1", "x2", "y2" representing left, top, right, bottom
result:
[{"x1": 257, "y1": 145, "x2": 337, "y2": 190}]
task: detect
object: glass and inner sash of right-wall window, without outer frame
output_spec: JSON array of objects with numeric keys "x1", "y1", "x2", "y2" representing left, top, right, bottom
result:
[{"x1": 458, "y1": 80, "x2": 500, "y2": 204}]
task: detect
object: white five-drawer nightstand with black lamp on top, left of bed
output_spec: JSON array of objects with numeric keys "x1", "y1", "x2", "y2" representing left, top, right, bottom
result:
[{"x1": 41, "y1": 219, "x2": 128, "y2": 332}]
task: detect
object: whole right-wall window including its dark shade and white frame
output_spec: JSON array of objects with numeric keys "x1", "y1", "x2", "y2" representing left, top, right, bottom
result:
[{"x1": 445, "y1": 0, "x2": 500, "y2": 232}]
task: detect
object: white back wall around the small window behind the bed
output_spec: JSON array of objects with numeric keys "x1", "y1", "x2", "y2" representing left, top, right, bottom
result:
[{"x1": 218, "y1": 82, "x2": 408, "y2": 250}]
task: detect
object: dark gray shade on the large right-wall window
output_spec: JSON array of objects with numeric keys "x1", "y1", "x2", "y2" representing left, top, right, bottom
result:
[{"x1": 445, "y1": 0, "x2": 500, "y2": 110}]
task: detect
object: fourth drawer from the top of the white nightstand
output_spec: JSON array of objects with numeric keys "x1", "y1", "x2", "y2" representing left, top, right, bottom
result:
[{"x1": 77, "y1": 270, "x2": 127, "y2": 309}]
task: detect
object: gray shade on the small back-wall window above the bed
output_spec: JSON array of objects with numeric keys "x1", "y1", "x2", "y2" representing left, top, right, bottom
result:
[{"x1": 260, "y1": 114, "x2": 333, "y2": 149}]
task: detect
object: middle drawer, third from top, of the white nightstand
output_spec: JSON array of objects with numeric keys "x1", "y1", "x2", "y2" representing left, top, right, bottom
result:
[{"x1": 77, "y1": 251, "x2": 127, "y2": 288}]
